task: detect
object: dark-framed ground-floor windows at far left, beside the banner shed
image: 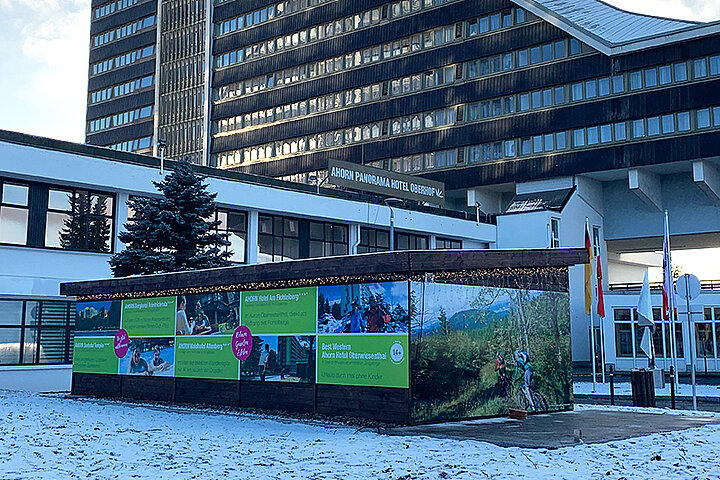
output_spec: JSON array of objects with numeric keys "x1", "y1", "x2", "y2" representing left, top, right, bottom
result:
[{"x1": 0, "y1": 300, "x2": 75, "y2": 365}]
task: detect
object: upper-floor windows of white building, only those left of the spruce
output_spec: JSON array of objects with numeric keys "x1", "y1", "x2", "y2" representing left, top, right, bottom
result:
[{"x1": 0, "y1": 180, "x2": 114, "y2": 252}]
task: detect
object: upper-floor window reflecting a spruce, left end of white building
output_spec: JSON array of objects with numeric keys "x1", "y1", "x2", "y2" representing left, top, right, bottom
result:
[{"x1": 45, "y1": 188, "x2": 114, "y2": 252}]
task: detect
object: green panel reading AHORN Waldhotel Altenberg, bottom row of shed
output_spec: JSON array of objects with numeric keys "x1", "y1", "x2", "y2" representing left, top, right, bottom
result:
[{"x1": 175, "y1": 336, "x2": 240, "y2": 380}]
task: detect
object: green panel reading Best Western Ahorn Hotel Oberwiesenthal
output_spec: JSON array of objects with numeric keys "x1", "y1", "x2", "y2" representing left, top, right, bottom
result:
[{"x1": 317, "y1": 334, "x2": 410, "y2": 388}]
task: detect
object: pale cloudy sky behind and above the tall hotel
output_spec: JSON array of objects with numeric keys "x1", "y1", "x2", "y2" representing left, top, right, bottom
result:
[{"x1": 0, "y1": 0, "x2": 720, "y2": 142}]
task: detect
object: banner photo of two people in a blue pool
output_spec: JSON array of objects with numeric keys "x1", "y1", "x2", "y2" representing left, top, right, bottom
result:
[{"x1": 119, "y1": 338, "x2": 175, "y2": 377}]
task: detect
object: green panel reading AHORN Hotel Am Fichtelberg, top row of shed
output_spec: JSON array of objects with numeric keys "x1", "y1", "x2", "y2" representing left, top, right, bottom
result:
[{"x1": 240, "y1": 287, "x2": 317, "y2": 335}]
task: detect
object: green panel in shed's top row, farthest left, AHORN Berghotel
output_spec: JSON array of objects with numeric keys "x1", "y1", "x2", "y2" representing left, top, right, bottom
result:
[{"x1": 122, "y1": 297, "x2": 176, "y2": 337}]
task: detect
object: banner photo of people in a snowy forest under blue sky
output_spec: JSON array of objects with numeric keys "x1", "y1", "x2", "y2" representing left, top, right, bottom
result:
[{"x1": 318, "y1": 282, "x2": 409, "y2": 334}]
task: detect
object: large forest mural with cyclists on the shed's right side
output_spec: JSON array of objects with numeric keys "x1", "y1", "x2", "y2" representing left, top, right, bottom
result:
[{"x1": 410, "y1": 282, "x2": 572, "y2": 422}]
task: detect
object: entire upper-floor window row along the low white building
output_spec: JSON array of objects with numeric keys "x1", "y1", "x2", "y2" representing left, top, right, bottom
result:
[{"x1": 0, "y1": 180, "x2": 462, "y2": 262}]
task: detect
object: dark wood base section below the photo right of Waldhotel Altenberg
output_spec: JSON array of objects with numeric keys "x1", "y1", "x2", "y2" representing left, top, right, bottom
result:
[{"x1": 240, "y1": 381, "x2": 315, "y2": 413}]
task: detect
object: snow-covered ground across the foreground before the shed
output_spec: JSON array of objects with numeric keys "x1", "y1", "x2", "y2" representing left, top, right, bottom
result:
[{"x1": 0, "y1": 392, "x2": 720, "y2": 480}]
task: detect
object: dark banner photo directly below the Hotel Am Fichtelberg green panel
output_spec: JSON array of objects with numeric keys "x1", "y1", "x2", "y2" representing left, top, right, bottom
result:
[{"x1": 241, "y1": 335, "x2": 315, "y2": 383}]
